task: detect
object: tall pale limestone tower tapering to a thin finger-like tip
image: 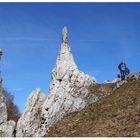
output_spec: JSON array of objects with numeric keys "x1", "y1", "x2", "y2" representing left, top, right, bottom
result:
[{"x1": 37, "y1": 27, "x2": 97, "y2": 136}]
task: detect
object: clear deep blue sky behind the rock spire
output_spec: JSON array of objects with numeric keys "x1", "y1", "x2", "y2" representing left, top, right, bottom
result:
[{"x1": 0, "y1": 3, "x2": 140, "y2": 112}]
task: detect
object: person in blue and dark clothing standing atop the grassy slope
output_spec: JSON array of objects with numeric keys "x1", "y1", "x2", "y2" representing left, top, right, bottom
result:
[{"x1": 118, "y1": 61, "x2": 127, "y2": 80}]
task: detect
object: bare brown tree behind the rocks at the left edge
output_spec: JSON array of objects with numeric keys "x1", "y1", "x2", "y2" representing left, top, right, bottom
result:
[{"x1": 2, "y1": 89, "x2": 21, "y2": 122}]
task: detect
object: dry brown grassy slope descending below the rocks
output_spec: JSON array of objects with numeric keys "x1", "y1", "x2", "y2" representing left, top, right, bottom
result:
[{"x1": 46, "y1": 80, "x2": 140, "y2": 137}]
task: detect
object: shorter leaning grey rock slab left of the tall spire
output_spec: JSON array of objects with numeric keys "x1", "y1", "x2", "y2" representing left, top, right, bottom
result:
[{"x1": 16, "y1": 89, "x2": 46, "y2": 137}]
